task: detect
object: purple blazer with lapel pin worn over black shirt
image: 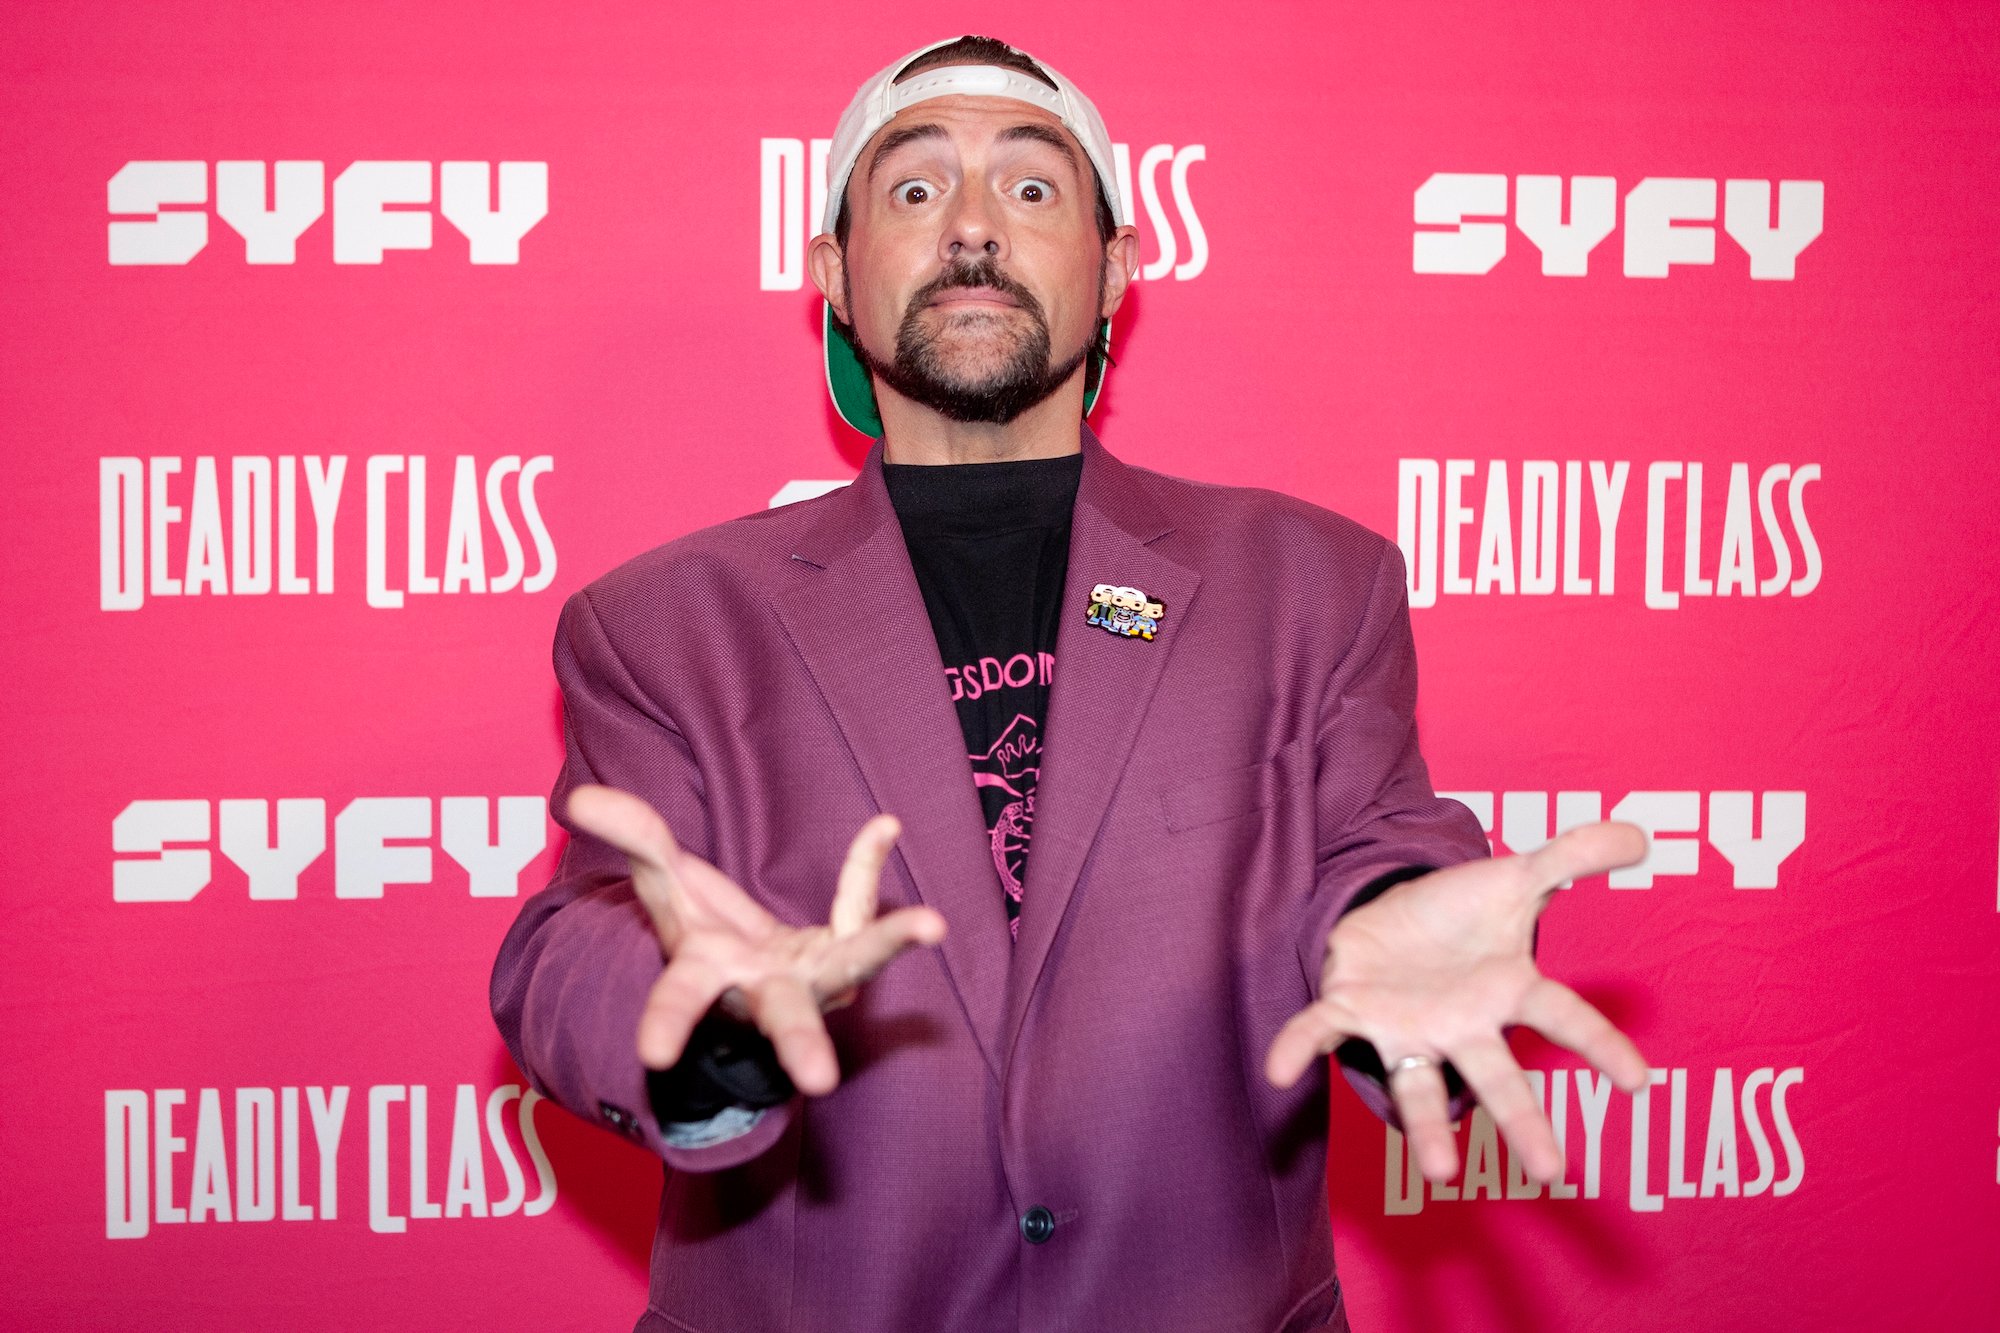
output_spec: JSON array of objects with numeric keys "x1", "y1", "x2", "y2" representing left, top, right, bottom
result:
[{"x1": 492, "y1": 426, "x2": 1490, "y2": 1333}]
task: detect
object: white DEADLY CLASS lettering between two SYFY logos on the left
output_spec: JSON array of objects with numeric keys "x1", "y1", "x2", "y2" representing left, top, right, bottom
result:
[{"x1": 98, "y1": 454, "x2": 556, "y2": 610}]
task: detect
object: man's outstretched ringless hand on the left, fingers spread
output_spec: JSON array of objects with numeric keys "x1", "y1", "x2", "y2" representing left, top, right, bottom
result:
[{"x1": 570, "y1": 785, "x2": 944, "y2": 1097}]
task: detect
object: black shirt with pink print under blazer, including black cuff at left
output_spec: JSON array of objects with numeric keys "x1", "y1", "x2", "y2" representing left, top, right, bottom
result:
[{"x1": 650, "y1": 452, "x2": 1084, "y2": 1123}]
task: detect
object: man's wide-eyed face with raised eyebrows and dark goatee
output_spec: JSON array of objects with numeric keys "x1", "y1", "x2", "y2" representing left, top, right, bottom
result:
[{"x1": 814, "y1": 94, "x2": 1136, "y2": 422}]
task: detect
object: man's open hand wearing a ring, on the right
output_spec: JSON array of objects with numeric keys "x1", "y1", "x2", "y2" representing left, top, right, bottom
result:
[{"x1": 1264, "y1": 821, "x2": 1646, "y2": 1181}]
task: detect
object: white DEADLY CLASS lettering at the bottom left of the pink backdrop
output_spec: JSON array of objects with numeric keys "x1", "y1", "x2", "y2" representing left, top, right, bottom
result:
[{"x1": 104, "y1": 1083, "x2": 556, "y2": 1241}]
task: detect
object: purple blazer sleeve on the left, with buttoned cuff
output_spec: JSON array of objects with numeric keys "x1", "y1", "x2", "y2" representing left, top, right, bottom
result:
[{"x1": 490, "y1": 590, "x2": 798, "y2": 1171}]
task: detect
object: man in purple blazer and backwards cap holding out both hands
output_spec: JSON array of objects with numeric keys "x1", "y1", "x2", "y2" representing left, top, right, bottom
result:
[{"x1": 494, "y1": 38, "x2": 1646, "y2": 1333}]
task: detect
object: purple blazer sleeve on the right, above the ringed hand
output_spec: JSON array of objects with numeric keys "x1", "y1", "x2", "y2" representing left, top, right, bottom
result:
[{"x1": 1298, "y1": 540, "x2": 1492, "y2": 1129}]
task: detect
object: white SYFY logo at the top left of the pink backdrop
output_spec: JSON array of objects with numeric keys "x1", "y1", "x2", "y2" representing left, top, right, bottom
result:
[{"x1": 104, "y1": 162, "x2": 548, "y2": 264}]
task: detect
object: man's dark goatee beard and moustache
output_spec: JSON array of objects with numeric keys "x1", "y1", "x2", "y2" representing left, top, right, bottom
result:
[{"x1": 842, "y1": 254, "x2": 1090, "y2": 424}]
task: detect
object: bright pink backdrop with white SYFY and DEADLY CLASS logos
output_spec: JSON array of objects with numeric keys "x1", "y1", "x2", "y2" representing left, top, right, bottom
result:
[{"x1": 0, "y1": 0, "x2": 2000, "y2": 1333}]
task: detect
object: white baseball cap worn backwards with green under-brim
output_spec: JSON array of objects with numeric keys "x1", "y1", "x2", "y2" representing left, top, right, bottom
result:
[{"x1": 820, "y1": 38, "x2": 1132, "y2": 434}]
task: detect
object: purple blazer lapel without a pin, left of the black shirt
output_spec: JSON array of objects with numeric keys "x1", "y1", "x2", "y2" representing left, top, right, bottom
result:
[{"x1": 774, "y1": 440, "x2": 1008, "y2": 1079}]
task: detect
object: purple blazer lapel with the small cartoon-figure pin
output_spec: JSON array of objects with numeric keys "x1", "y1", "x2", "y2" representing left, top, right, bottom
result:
[{"x1": 1002, "y1": 426, "x2": 1202, "y2": 1071}]
